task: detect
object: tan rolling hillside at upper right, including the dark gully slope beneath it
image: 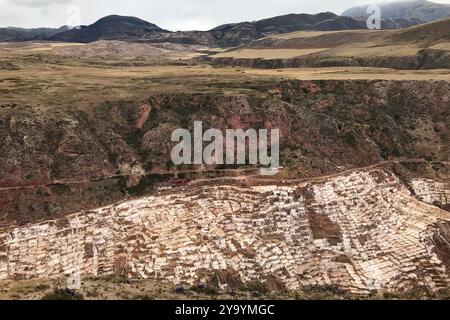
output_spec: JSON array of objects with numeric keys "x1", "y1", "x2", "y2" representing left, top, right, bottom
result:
[{"x1": 208, "y1": 19, "x2": 450, "y2": 69}]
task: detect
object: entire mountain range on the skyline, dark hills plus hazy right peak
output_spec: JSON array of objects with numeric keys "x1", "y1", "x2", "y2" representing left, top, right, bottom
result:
[{"x1": 0, "y1": 1, "x2": 450, "y2": 47}]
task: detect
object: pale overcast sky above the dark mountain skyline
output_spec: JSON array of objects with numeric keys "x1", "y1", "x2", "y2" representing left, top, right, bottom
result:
[{"x1": 0, "y1": 0, "x2": 450, "y2": 31}]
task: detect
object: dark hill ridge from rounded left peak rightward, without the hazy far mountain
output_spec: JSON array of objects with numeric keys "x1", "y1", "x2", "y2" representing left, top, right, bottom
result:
[{"x1": 48, "y1": 12, "x2": 420, "y2": 47}]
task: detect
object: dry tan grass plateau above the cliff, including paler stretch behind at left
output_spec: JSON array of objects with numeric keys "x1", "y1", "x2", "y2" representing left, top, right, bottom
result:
[{"x1": 0, "y1": 42, "x2": 450, "y2": 110}]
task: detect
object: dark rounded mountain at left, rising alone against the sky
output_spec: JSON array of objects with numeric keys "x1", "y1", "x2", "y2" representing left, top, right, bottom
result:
[{"x1": 49, "y1": 15, "x2": 168, "y2": 43}]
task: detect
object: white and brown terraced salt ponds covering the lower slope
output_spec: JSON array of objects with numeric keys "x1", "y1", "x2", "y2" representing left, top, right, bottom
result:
[{"x1": 0, "y1": 169, "x2": 450, "y2": 294}]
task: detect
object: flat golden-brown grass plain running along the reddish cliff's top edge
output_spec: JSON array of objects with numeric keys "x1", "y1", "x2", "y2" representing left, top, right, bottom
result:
[{"x1": 0, "y1": 65, "x2": 450, "y2": 111}]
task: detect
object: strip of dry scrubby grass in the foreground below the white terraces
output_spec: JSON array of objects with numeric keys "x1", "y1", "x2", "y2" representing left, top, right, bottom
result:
[{"x1": 0, "y1": 276, "x2": 449, "y2": 300}]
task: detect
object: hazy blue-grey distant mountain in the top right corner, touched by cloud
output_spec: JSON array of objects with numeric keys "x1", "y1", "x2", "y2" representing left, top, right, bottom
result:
[{"x1": 342, "y1": 0, "x2": 450, "y2": 22}]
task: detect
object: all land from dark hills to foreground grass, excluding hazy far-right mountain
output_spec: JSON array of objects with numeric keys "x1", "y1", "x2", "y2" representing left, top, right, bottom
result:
[{"x1": 0, "y1": 3, "x2": 450, "y2": 300}]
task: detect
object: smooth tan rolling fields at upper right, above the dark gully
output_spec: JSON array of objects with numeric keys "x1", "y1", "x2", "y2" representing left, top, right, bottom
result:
[{"x1": 212, "y1": 19, "x2": 450, "y2": 65}]
